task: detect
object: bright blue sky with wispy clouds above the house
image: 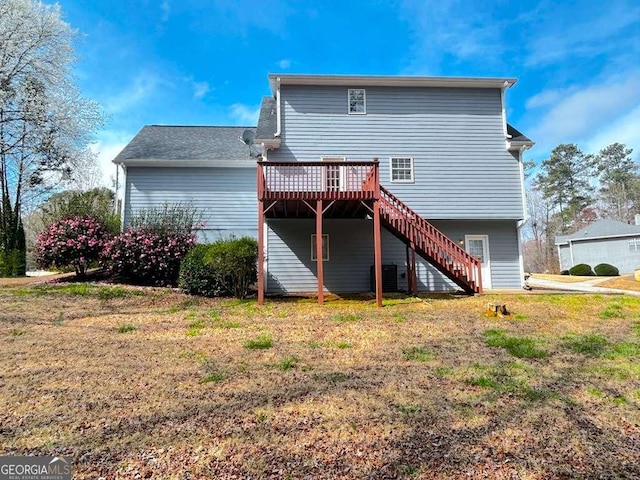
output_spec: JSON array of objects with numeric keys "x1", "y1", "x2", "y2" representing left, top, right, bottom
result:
[{"x1": 59, "y1": 0, "x2": 640, "y2": 186}]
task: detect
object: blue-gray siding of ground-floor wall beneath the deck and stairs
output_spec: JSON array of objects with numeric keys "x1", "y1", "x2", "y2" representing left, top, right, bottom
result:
[{"x1": 266, "y1": 219, "x2": 522, "y2": 294}]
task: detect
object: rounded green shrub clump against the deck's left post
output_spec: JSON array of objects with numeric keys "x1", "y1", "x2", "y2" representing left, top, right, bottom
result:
[{"x1": 179, "y1": 237, "x2": 258, "y2": 298}]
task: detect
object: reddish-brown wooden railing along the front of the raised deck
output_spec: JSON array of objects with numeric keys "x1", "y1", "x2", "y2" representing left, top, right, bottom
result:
[{"x1": 258, "y1": 160, "x2": 380, "y2": 200}]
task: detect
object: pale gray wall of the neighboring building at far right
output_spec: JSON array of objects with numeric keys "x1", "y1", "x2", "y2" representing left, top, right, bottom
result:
[{"x1": 560, "y1": 236, "x2": 640, "y2": 274}]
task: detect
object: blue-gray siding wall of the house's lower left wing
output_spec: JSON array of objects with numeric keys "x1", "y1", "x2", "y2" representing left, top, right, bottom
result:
[{"x1": 124, "y1": 167, "x2": 258, "y2": 242}]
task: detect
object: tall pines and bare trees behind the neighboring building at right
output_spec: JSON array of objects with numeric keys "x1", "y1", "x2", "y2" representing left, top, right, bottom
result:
[{"x1": 524, "y1": 143, "x2": 640, "y2": 272}]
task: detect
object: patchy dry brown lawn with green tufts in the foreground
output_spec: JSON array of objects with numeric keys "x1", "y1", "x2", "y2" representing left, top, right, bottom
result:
[{"x1": 0, "y1": 284, "x2": 640, "y2": 479}]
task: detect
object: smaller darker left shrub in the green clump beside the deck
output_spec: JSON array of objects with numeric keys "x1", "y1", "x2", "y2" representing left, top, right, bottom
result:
[{"x1": 178, "y1": 244, "x2": 225, "y2": 297}]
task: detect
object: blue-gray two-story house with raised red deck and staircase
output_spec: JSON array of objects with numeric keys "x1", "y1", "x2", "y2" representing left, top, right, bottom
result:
[{"x1": 114, "y1": 75, "x2": 533, "y2": 301}]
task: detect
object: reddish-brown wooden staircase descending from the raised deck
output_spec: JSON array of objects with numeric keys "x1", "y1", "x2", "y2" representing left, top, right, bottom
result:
[{"x1": 378, "y1": 185, "x2": 482, "y2": 294}]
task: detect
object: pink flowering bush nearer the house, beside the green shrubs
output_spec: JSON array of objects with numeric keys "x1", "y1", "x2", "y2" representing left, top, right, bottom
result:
[{"x1": 102, "y1": 227, "x2": 196, "y2": 285}]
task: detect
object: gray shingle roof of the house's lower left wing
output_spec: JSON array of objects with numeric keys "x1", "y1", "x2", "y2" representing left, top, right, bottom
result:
[{"x1": 113, "y1": 125, "x2": 255, "y2": 165}]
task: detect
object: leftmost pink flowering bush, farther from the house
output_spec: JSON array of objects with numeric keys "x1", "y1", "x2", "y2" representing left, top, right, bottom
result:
[{"x1": 36, "y1": 216, "x2": 111, "y2": 276}]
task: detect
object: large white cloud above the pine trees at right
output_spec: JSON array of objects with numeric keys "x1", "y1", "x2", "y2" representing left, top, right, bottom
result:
[{"x1": 527, "y1": 70, "x2": 640, "y2": 152}]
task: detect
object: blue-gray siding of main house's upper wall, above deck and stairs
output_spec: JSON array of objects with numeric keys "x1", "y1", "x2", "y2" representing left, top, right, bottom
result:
[{"x1": 268, "y1": 85, "x2": 523, "y2": 220}]
